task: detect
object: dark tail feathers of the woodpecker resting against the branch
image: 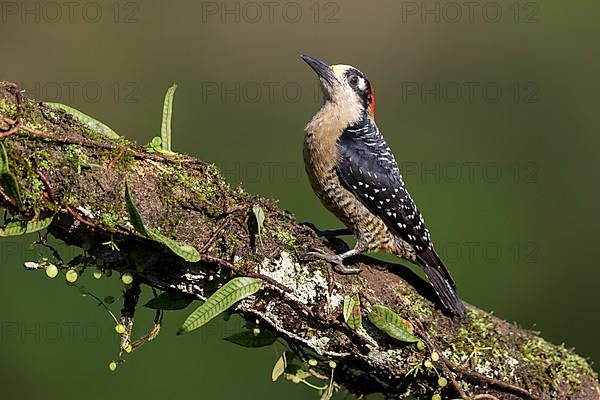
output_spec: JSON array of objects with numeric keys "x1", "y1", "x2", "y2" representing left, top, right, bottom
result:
[{"x1": 417, "y1": 249, "x2": 466, "y2": 317}]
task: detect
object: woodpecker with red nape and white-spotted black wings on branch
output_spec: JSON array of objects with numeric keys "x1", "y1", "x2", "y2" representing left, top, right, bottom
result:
[{"x1": 302, "y1": 55, "x2": 465, "y2": 317}]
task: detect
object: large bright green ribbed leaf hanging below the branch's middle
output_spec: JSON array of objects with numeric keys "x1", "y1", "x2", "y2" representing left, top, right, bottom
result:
[{"x1": 178, "y1": 277, "x2": 262, "y2": 334}]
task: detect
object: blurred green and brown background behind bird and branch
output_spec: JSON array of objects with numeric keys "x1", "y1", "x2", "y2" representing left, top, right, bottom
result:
[{"x1": 0, "y1": 0, "x2": 600, "y2": 400}]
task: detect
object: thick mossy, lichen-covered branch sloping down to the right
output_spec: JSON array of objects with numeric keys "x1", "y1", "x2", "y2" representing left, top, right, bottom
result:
[{"x1": 0, "y1": 82, "x2": 600, "y2": 399}]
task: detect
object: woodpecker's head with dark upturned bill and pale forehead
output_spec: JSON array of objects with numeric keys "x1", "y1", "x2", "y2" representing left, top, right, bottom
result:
[{"x1": 301, "y1": 55, "x2": 375, "y2": 119}]
